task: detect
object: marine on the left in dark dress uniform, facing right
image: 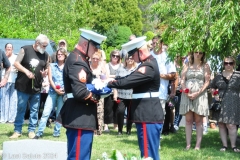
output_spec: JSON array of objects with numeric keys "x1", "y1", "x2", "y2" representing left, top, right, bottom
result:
[{"x1": 57, "y1": 29, "x2": 107, "y2": 160}]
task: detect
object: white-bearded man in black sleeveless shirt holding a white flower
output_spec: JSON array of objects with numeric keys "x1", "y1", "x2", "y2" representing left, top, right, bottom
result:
[{"x1": 9, "y1": 34, "x2": 49, "y2": 139}]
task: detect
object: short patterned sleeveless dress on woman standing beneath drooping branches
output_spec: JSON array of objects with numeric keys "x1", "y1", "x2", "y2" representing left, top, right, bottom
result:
[{"x1": 179, "y1": 66, "x2": 209, "y2": 116}]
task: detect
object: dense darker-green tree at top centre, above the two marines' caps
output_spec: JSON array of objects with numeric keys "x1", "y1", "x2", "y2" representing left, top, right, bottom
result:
[{"x1": 91, "y1": 0, "x2": 143, "y2": 36}]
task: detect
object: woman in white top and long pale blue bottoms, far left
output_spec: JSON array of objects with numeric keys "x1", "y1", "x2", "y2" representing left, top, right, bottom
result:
[{"x1": 0, "y1": 43, "x2": 17, "y2": 123}]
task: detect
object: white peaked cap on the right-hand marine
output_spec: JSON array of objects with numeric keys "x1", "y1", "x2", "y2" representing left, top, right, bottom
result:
[{"x1": 122, "y1": 36, "x2": 147, "y2": 52}]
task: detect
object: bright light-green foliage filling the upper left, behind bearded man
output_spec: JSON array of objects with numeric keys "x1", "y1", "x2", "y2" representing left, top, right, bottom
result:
[{"x1": 0, "y1": 0, "x2": 93, "y2": 48}]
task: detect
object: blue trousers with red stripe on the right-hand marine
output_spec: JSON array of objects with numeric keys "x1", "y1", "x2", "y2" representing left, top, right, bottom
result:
[{"x1": 136, "y1": 123, "x2": 163, "y2": 160}]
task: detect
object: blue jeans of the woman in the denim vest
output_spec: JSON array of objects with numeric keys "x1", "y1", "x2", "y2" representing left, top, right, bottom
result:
[{"x1": 36, "y1": 92, "x2": 63, "y2": 136}]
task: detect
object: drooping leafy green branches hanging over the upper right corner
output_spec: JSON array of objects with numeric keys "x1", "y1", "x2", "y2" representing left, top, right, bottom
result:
[{"x1": 152, "y1": 0, "x2": 240, "y2": 70}]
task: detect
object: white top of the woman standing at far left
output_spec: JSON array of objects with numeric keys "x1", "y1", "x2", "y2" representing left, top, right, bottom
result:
[{"x1": 2, "y1": 54, "x2": 17, "y2": 83}]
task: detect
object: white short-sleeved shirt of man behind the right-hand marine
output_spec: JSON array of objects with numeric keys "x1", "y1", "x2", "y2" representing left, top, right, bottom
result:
[{"x1": 151, "y1": 51, "x2": 176, "y2": 100}]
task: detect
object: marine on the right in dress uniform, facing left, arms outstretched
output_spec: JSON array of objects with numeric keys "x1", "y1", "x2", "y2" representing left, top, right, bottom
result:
[{"x1": 108, "y1": 36, "x2": 164, "y2": 160}]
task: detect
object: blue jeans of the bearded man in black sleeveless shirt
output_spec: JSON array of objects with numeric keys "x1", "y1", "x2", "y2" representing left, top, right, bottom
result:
[{"x1": 14, "y1": 91, "x2": 40, "y2": 133}]
